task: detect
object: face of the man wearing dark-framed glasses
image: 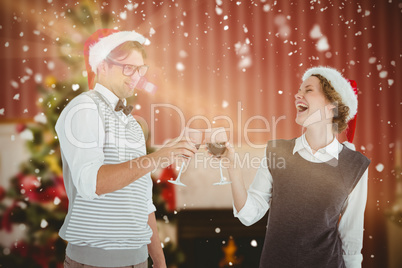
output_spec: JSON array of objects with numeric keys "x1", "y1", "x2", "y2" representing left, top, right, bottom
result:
[{"x1": 98, "y1": 50, "x2": 144, "y2": 99}]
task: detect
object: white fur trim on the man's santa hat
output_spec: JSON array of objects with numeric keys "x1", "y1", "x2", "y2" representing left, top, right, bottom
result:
[{"x1": 88, "y1": 31, "x2": 149, "y2": 73}]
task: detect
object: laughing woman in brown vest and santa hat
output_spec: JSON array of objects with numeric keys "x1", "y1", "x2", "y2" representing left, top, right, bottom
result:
[{"x1": 226, "y1": 67, "x2": 370, "y2": 268}]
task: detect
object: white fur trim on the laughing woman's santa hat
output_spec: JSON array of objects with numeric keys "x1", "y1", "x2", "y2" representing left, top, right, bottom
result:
[{"x1": 302, "y1": 66, "x2": 357, "y2": 121}]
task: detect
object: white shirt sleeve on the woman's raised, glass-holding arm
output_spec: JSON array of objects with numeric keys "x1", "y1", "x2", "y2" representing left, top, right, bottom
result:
[{"x1": 233, "y1": 157, "x2": 272, "y2": 226}]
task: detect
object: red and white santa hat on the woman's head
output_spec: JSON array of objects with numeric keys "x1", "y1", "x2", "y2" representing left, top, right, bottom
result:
[{"x1": 302, "y1": 66, "x2": 357, "y2": 142}]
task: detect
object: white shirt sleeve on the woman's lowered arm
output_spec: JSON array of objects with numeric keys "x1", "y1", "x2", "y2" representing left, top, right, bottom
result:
[{"x1": 339, "y1": 169, "x2": 368, "y2": 268}]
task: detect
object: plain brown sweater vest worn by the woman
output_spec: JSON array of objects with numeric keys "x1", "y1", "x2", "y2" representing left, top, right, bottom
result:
[{"x1": 260, "y1": 139, "x2": 370, "y2": 268}]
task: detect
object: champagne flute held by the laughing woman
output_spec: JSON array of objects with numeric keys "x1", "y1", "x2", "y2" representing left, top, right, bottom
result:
[{"x1": 205, "y1": 127, "x2": 232, "y2": 185}]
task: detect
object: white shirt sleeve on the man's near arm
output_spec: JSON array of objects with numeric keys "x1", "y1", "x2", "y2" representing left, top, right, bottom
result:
[{"x1": 56, "y1": 95, "x2": 105, "y2": 199}]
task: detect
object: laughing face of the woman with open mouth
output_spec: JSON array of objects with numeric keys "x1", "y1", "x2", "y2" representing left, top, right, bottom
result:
[{"x1": 295, "y1": 76, "x2": 335, "y2": 127}]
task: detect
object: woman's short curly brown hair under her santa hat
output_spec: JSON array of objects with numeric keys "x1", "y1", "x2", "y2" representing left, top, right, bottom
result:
[{"x1": 312, "y1": 74, "x2": 349, "y2": 133}]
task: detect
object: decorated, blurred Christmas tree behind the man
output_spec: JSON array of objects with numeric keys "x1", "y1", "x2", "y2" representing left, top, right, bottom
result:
[{"x1": 0, "y1": 1, "x2": 183, "y2": 268}]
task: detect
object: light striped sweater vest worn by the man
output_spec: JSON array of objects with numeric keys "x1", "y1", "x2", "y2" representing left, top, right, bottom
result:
[{"x1": 60, "y1": 90, "x2": 152, "y2": 250}]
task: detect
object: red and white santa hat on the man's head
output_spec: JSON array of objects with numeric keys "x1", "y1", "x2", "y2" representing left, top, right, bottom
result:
[{"x1": 84, "y1": 29, "x2": 148, "y2": 89}]
